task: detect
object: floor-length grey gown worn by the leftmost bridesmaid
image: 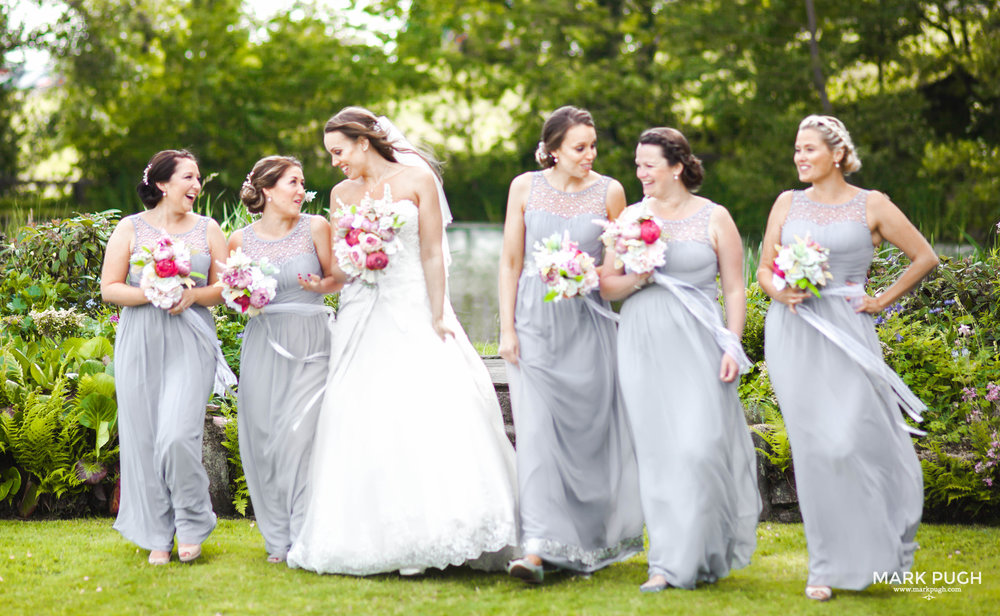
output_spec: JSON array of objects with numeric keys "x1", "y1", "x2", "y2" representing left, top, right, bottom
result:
[{"x1": 114, "y1": 214, "x2": 218, "y2": 551}]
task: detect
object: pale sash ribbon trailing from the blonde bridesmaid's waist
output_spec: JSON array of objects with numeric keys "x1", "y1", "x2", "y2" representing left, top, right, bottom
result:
[{"x1": 796, "y1": 285, "x2": 927, "y2": 436}]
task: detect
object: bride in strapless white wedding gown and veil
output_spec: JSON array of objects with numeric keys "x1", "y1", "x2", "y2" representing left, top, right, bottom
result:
[{"x1": 288, "y1": 107, "x2": 517, "y2": 575}]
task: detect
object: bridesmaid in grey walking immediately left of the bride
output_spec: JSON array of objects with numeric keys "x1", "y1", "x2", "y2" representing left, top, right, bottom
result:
[{"x1": 229, "y1": 156, "x2": 346, "y2": 563}]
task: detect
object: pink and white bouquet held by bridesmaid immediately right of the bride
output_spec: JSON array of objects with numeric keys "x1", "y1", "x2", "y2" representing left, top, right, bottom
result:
[{"x1": 535, "y1": 231, "x2": 600, "y2": 302}]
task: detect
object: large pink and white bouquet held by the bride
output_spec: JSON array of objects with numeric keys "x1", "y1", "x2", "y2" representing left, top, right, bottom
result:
[{"x1": 333, "y1": 186, "x2": 405, "y2": 284}]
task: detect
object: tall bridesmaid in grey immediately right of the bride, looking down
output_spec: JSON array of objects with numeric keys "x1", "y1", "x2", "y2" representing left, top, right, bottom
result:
[{"x1": 500, "y1": 106, "x2": 642, "y2": 584}]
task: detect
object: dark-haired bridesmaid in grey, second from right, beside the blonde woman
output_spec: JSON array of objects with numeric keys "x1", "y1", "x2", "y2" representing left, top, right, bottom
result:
[{"x1": 601, "y1": 128, "x2": 761, "y2": 592}]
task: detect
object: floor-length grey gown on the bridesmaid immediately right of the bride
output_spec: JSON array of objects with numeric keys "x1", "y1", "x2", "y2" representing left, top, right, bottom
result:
[{"x1": 507, "y1": 172, "x2": 642, "y2": 572}]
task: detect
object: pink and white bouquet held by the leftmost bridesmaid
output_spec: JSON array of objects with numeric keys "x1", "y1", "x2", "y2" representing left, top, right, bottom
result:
[{"x1": 129, "y1": 234, "x2": 205, "y2": 310}]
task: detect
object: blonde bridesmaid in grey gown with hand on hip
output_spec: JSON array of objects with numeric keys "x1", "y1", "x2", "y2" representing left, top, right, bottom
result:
[{"x1": 757, "y1": 115, "x2": 938, "y2": 601}]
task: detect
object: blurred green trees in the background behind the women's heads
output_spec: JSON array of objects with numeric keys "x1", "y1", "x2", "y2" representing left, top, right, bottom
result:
[{"x1": 0, "y1": 0, "x2": 1000, "y2": 241}]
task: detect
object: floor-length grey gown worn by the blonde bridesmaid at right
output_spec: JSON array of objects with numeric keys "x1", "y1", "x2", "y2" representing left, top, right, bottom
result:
[{"x1": 764, "y1": 191, "x2": 923, "y2": 590}]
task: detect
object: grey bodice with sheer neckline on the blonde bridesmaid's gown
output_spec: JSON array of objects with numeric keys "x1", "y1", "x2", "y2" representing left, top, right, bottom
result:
[{"x1": 781, "y1": 190, "x2": 875, "y2": 286}]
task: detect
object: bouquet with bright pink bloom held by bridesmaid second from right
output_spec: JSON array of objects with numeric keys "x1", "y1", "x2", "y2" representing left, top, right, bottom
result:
[{"x1": 594, "y1": 202, "x2": 667, "y2": 274}]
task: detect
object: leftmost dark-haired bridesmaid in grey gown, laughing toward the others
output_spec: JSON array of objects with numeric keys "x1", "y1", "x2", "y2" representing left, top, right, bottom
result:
[{"x1": 101, "y1": 150, "x2": 232, "y2": 565}]
